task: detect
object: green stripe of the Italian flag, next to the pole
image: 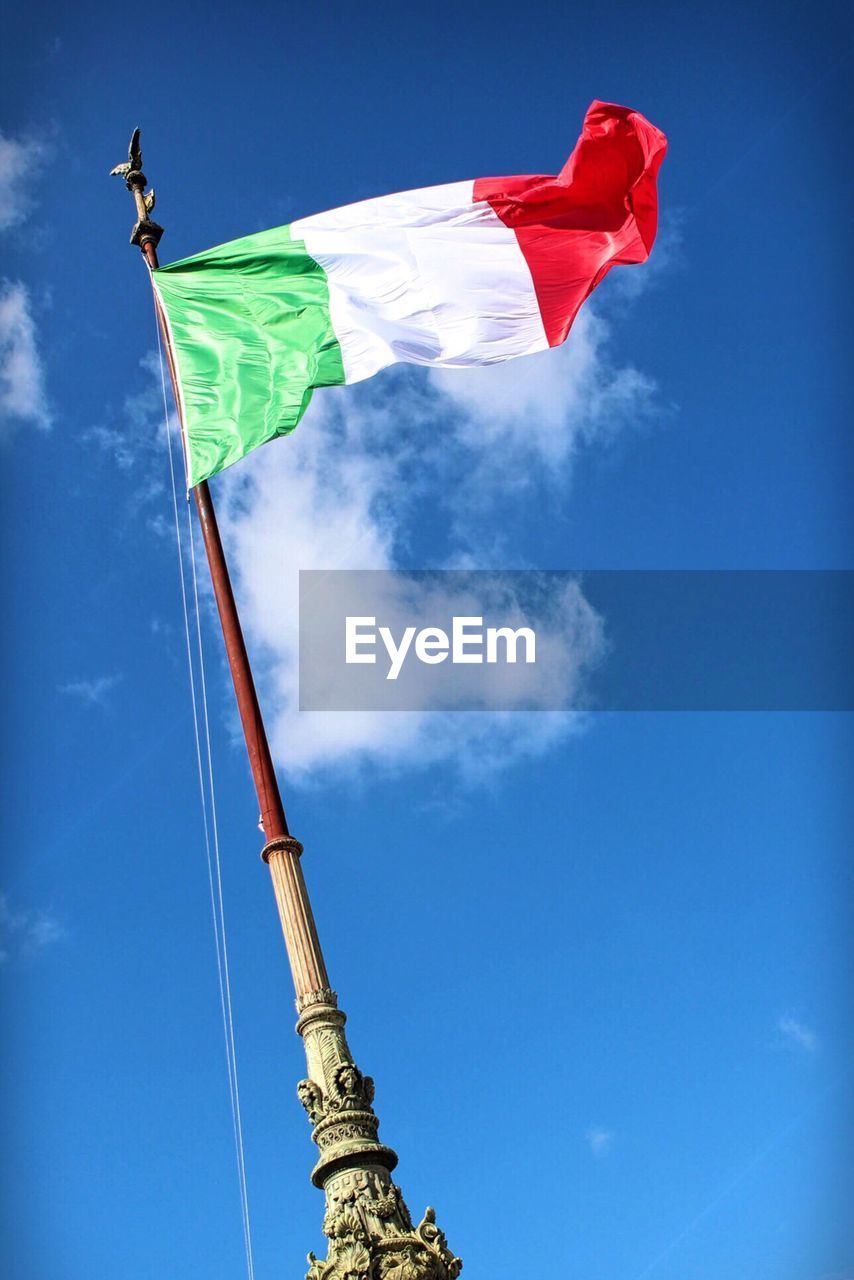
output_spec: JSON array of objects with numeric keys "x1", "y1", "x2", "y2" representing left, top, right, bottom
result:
[{"x1": 154, "y1": 227, "x2": 344, "y2": 485}]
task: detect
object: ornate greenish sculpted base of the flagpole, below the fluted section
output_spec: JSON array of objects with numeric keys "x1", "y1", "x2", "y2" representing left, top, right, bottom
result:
[{"x1": 297, "y1": 988, "x2": 462, "y2": 1280}]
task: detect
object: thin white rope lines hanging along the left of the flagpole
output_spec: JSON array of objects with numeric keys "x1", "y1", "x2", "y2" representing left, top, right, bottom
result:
[{"x1": 156, "y1": 324, "x2": 255, "y2": 1280}]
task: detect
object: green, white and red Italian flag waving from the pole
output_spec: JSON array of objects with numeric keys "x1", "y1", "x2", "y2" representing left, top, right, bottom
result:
[{"x1": 154, "y1": 102, "x2": 667, "y2": 485}]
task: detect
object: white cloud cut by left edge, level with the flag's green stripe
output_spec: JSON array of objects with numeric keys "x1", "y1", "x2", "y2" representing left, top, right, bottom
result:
[{"x1": 0, "y1": 280, "x2": 50, "y2": 435}]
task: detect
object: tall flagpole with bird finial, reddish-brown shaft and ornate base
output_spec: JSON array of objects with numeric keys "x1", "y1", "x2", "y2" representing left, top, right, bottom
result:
[{"x1": 111, "y1": 129, "x2": 462, "y2": 1280}]
